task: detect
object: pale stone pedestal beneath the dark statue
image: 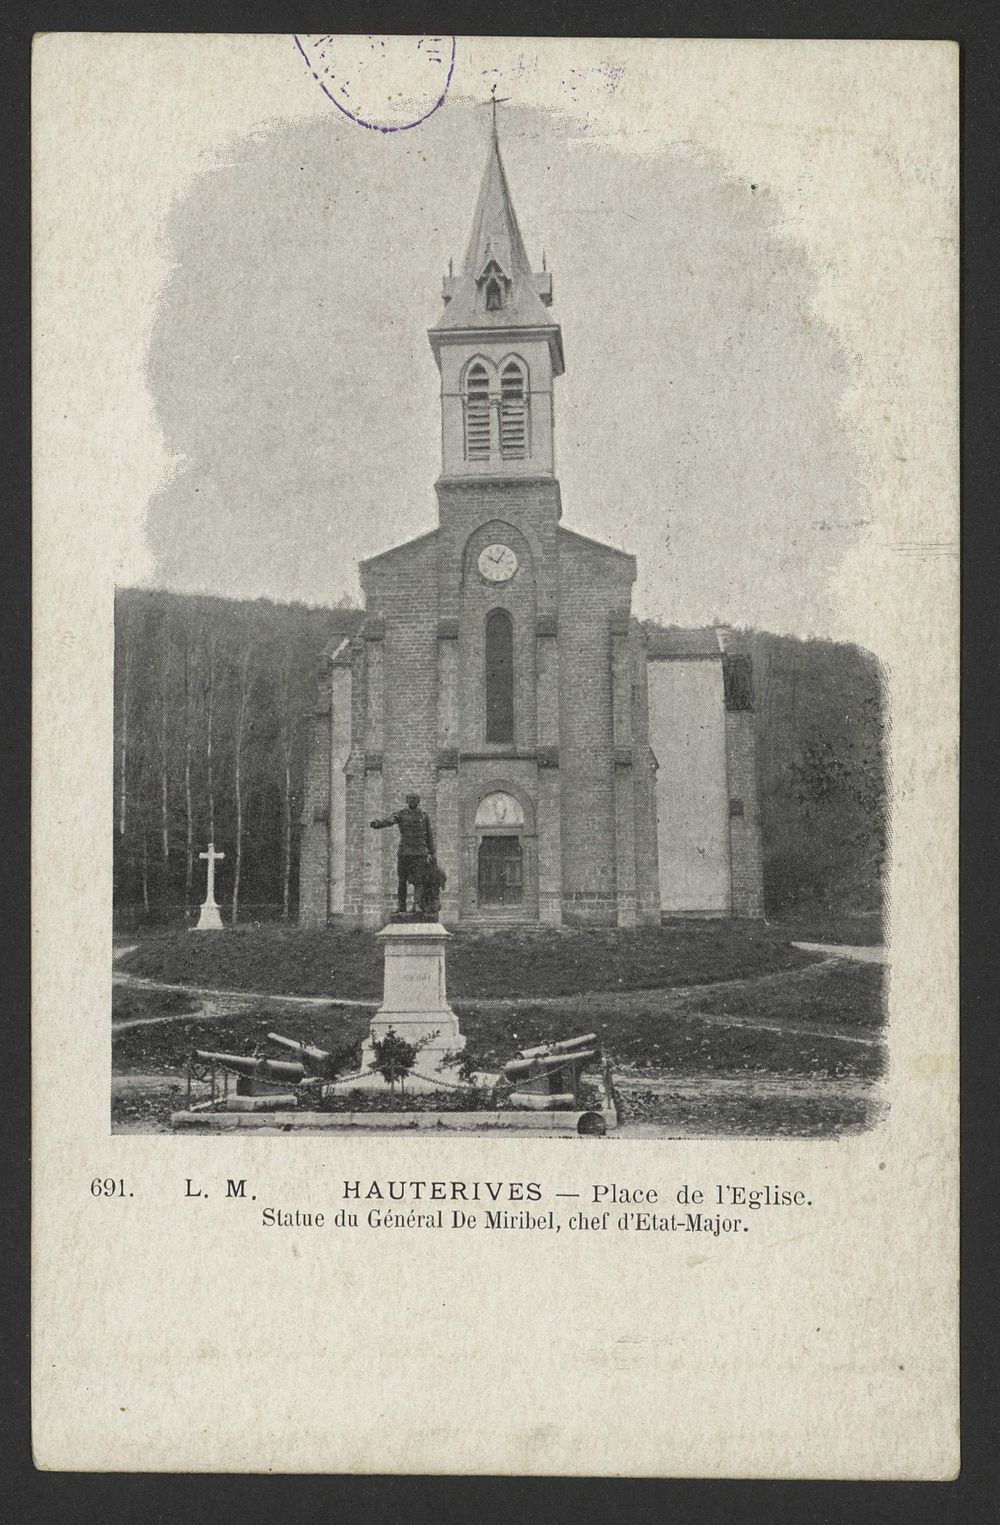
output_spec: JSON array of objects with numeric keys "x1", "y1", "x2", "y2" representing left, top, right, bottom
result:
[{"x1": 361, "y1": 921, "x2": 465, "y2": 1090}]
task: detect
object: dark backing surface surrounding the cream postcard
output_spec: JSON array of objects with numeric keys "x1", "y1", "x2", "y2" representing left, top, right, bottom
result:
[{"x1": 0, "y1": 0, "x2": 1000, "y2": 1525}]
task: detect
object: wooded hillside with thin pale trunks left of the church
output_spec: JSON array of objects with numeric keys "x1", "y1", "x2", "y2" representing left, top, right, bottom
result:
[{"x1": 114, "y1": 589, "x2": 358, "y2": 923}]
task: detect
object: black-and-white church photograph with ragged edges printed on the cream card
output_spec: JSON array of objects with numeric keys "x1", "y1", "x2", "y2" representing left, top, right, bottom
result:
[{"x1": 111, "y1": 37, "x2": 890, "y2": 1138}]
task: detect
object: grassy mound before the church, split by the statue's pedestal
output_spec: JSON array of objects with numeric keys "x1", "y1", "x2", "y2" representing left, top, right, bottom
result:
[{"x1": 117, "y1": 921, "x2": 814, "y2": 1000}]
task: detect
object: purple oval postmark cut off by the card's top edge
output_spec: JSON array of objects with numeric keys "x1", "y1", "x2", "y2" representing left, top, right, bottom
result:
[{"x1": 296, "y1": 32, "x2": 454, "y2": 133}]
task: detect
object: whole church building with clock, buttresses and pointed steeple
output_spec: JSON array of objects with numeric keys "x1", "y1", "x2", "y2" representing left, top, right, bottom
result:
[{"x1": 299, "y1": 127, "x2": 762, "y2": 927}]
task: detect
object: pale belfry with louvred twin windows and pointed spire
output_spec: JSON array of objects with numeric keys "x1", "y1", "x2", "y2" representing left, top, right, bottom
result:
[{"x1": 430, "y1": 113, "x2": 564, "y2": 482}]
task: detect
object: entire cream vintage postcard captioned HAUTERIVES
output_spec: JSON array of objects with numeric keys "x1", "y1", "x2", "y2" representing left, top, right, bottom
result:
[{"x1": 32, "y1": 34, "x2": 959, "y2": 1479}]
